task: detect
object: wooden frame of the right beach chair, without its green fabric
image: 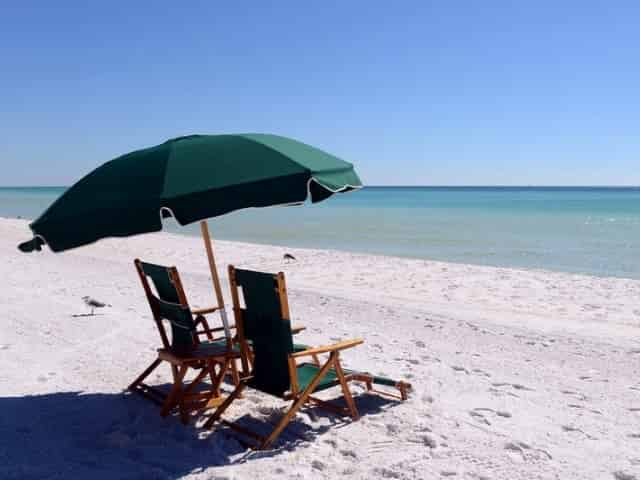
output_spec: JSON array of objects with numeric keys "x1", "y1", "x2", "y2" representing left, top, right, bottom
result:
[{"x1": 204, "y1": 265, "x2": 380, "y2": 449}]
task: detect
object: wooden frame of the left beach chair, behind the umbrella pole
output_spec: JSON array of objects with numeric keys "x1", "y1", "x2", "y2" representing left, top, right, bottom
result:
[{"x1": 128, "y1": 259, "x2": 239, "y2": 424}]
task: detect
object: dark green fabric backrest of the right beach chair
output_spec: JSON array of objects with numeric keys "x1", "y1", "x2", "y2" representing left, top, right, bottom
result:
[{"x1": 235, "y1": 269, "x2": 293, "y2": 396}]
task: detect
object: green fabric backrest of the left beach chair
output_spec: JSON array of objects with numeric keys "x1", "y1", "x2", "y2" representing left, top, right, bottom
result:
[{"x1": 139, "y1": 262, "x2": 196, "y2": 355}]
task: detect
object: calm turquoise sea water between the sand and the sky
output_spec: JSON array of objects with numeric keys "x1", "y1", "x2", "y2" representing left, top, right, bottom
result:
[{"x1": 0, "y1": 187, "x2": 640, "y2": 279}]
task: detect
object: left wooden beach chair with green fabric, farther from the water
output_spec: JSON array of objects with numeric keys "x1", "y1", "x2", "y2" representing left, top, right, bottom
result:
[{"x1": 129, "y1": 259, "x2": 239, "y2": 423}]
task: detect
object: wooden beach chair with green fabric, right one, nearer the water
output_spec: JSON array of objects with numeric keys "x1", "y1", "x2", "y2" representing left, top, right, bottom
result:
[{"x1": 204, "y1": 266, "x2": 411, "y2": 449}]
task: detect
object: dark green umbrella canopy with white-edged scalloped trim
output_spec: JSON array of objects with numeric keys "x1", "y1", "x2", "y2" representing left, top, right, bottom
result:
[{"x1": 19, "y1": 134, "x2": 362, "y2": 252}]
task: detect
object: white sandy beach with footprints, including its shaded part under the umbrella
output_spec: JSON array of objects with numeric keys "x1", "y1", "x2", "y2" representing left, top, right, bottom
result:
[{"x1": 0, "y1": 219, "x2": 640, "y2": 479}]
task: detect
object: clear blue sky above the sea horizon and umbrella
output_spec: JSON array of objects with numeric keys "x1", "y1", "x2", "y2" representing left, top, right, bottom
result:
[{"x1": 0, "y1": 0, "x2": 640, "y2": 185}]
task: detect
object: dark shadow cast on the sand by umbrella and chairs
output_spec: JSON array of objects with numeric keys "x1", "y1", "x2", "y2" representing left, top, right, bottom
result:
[{"x1": 0, "y1": 385, "x2": 397, "y2": 480}]
